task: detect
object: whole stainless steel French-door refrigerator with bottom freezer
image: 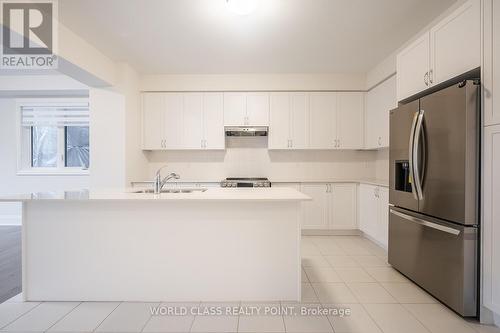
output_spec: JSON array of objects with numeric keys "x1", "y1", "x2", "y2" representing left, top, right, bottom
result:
[{"x1": 389, "y1": 80, "x2": 480, "y2": 316}]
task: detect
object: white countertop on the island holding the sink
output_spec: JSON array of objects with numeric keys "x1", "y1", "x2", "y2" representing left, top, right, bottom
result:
[{"x1": 0, "y1": 187, "x2": 311, "y2": 202}]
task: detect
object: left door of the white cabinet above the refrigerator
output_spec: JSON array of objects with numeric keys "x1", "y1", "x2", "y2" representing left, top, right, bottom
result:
[{"x1": 397, "y1": 32, "x2": 430, "y2": 101}]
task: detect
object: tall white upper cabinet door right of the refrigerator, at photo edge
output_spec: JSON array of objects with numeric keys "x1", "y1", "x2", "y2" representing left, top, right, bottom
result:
[{"x1": 481, "y1": 0, "x2": 500, "y2": 126}]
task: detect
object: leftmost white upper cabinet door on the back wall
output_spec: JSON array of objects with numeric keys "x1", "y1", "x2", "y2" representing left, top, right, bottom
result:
[{"x1": 142, "y1": 93, "x2": 165, "y2": 150}]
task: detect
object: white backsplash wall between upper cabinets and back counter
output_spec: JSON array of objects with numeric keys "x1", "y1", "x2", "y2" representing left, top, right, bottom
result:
[{"x1": 143, "y1": 137, "x2": 375, "y2": 182}]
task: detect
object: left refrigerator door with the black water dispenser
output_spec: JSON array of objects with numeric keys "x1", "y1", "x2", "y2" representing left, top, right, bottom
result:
[{"x1": 389, "y1": 100, "x2": 419, "y2": 211}]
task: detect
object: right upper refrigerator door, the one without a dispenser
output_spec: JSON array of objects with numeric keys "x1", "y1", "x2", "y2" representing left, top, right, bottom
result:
[{"x1": 415, "y1": 81, "x2": 479, "y2": 225}]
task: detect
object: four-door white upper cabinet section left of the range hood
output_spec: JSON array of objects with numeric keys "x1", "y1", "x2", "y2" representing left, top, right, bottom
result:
[{"x1": 142, "y1": 93, "x2": 225, "y2": 150}]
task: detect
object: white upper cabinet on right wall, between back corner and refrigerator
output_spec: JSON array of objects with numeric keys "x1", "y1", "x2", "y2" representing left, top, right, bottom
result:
[{"x1": 365, "y1": 75, "x2": 398, "y2": 149}]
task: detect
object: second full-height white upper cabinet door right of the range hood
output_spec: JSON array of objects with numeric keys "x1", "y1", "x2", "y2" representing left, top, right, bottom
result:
[{"x1": 290, "y1": 93, "x2": 309, "y2": 149}]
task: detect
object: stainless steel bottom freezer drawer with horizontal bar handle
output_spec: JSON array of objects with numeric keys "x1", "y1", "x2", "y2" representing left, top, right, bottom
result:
[{"x1": 389, "y1": 207, "x2": 478, "y2": 317}]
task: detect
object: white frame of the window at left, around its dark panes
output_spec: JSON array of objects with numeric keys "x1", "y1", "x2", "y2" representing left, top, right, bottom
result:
[{"x1": 16, "y1": 98, "x2": 90, "y2": 176}]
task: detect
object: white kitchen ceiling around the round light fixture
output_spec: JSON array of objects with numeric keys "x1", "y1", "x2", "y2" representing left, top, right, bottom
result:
[{"x1": 59, "y1": 0, "x2": 455, "y2": 74}]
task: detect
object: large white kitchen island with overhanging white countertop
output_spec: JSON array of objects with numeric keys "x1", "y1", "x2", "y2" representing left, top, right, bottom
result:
[{"x1": 0, "y1": 188, "x2": 309, "y2": 302}]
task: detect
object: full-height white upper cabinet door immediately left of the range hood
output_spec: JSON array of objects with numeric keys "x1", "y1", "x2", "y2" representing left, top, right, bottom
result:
[{"x1": 203, "y1": 93, "x2": 226, "y2": 149}]
